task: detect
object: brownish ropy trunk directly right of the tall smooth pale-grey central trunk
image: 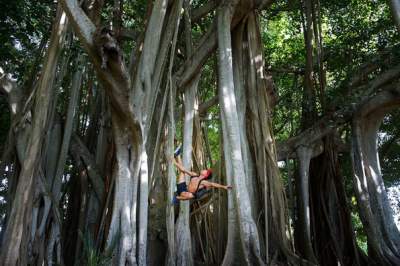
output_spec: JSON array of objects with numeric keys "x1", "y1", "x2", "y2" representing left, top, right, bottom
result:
[{"x1": 241, "y1": 12, "x2": 299, "y2": 264}]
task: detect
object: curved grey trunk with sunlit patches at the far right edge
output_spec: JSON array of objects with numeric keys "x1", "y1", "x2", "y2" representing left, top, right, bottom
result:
[{"x1": 351, "y1": 84, "x2": 400, "y2": 265}]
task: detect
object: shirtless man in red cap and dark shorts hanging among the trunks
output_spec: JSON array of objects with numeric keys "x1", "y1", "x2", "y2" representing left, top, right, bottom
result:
[{"x1": 174, "y1": 156, "x2": 232, "y2": 203}]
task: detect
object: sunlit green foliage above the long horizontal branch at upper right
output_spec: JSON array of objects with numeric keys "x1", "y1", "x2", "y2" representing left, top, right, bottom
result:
[{"x1": 260, "y1": 0, "x2": 400, "y2": 140}]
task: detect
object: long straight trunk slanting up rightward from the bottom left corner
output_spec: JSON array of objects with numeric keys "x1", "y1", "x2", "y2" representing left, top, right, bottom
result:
[{"x1": 0, "y1": 5, "x2": 68, "y2": 265}]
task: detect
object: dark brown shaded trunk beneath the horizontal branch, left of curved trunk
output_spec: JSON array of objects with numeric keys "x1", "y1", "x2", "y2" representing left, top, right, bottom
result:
[{"x1": 310, "y1": 134, "x2": 367, "y2": 266}]
